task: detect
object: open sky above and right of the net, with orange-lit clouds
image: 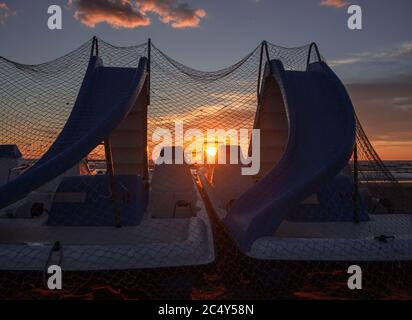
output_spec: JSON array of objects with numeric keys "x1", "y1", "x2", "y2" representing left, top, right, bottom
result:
[{"x1": 0, "y1": 0, "x2": 412, "y2": 160}]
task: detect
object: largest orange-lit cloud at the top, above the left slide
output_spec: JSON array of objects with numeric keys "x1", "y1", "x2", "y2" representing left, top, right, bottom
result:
[{"x1": 68, "y1": 0, "x2": 206, "y2": 29}]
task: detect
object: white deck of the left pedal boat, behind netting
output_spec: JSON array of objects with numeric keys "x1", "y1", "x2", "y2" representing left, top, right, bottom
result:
[{"x1": 0, "y1": 186, "x2": 214, "y2": 271}]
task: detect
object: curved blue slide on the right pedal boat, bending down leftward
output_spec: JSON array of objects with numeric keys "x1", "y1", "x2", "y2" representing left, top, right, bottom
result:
[{"x1": 223, "y1": 60, "x2": 356, "y2": 252}]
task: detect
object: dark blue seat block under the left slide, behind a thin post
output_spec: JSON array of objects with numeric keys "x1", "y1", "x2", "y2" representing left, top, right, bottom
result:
[{"x1": 47, "y1": 175, "x2": 147, "y2": 226}]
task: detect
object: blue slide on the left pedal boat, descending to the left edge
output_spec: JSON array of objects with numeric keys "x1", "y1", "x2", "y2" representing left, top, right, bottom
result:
[{"x1": 0, "y1": 56, "x2": 147, "y2": 208}]
